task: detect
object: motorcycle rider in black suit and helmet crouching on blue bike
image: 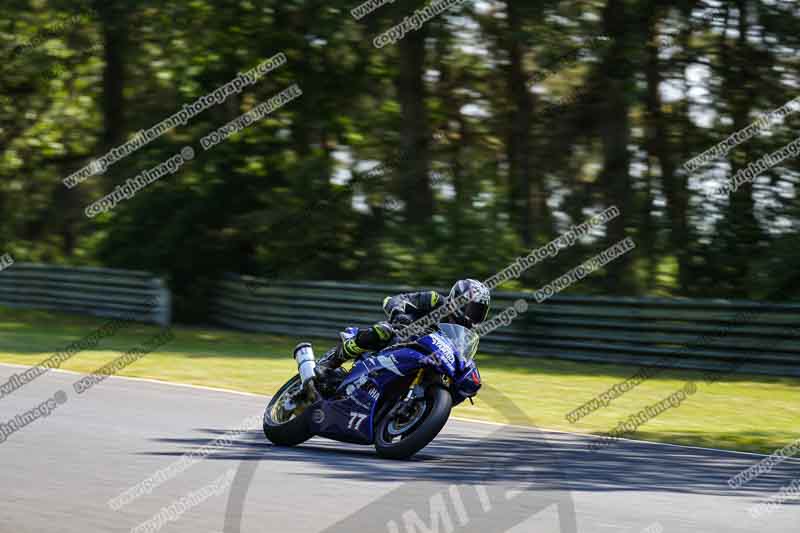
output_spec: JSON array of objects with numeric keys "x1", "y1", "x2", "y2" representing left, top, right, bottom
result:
[{"x1": 316, "y1": 279, "x2": 491, "y2": 381}]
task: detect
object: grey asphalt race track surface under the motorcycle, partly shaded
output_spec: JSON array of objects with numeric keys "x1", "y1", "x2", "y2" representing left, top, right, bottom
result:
[{"x1": 0, "y1": 365, "x2": 800, "y2": 533}]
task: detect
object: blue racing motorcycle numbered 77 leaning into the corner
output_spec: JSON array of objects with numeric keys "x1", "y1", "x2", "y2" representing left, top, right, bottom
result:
[{"x1": 264, "y1": 324, "x2": 481, "y2": 459}]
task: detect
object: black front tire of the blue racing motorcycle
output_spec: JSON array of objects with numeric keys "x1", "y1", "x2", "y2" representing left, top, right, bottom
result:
[{"x1": 375, "y1": 385, "x2": 453, "y2": 459}]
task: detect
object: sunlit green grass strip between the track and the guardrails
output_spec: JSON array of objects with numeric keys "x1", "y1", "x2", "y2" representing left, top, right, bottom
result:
[{"x1": 0, "y1": 308, "x2": 800, "y2": 453}]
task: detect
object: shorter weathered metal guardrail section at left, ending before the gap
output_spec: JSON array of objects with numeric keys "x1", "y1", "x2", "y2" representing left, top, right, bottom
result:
[{"x1": 0, "y1": 263, "x2": 171, "y2": 326}]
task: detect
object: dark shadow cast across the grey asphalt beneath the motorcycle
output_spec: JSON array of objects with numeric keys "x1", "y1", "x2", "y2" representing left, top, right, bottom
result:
[{"x1": 142, "y1": 421, "x2": 800, "y2": 497}]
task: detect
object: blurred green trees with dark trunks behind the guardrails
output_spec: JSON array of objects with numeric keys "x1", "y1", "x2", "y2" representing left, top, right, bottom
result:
[{"x1": 0, "y1": 0, "x2": 800, "y2": 320}]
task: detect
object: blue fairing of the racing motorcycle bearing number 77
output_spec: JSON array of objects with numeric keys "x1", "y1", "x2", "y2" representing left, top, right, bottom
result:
[{"x1": 311, "y1": 322, "x2": 480, "y2": 444}]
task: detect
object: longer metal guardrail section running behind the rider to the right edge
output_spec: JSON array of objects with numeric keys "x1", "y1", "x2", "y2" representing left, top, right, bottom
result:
[{"x1": 213, "y1": 274, "x2": 800, "y2": 376}]
